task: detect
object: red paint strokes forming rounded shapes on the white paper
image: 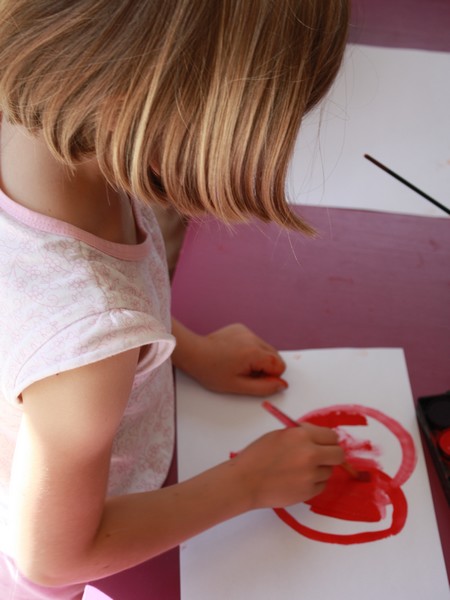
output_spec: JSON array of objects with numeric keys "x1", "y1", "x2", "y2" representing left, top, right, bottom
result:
[{"x1": 274, "y1": 404, "x2": 416, "y2": 545}]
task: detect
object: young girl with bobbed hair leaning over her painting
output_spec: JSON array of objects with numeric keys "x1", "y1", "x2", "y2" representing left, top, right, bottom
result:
[{"x1": 0, "y1": 0, "x2": 348, "y2": 600}]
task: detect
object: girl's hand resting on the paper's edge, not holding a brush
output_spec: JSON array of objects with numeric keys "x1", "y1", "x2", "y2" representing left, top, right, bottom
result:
[{"x1": 173, "y1": 321, "x2": 288, "y2": 396}]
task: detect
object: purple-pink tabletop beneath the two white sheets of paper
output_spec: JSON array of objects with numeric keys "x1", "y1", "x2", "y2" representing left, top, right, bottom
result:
[{"x1": 88, "y1": 0, "x2": 450, "y2": 600}]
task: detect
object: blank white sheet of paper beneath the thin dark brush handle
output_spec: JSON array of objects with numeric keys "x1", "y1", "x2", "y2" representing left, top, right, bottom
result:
[{"x1": 287, "y1": 45, "x2": 450, "y2": 217}]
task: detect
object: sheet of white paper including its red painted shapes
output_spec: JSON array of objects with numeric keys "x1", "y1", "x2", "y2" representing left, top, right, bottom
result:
[{"x1": 177, "y1": 349, "x2": 449, "y2": 600}]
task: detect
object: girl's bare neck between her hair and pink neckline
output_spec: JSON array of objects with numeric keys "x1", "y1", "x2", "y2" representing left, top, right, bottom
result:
[{"x1": 0, "y1": 119, "x2": 136, "y2": 244}]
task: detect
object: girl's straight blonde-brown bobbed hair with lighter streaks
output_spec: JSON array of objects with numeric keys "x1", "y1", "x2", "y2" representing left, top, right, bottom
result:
[{"x1": 0, "y1": 0, "x2": 348, "y2": 233}]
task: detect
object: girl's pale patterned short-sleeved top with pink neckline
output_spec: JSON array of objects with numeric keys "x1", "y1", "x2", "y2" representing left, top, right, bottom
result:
[{"x1": 0, "y1": 192, "x2": 175, "y2": 598}]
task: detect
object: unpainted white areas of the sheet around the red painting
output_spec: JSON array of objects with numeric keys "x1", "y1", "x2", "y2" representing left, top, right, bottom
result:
[{"x1": 177, "y1": 349, "x2": 449, "y2": 600}]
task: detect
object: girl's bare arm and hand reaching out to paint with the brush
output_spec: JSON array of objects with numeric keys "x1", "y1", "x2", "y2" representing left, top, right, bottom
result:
[{"x1": 12, "y1": 350, "x2": 343, "y2": 585}]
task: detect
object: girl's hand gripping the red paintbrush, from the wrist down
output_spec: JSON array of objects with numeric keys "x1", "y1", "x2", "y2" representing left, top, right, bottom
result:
[{"x1": 230, "y1": 423, "x2": 344, "y2": 510}]
